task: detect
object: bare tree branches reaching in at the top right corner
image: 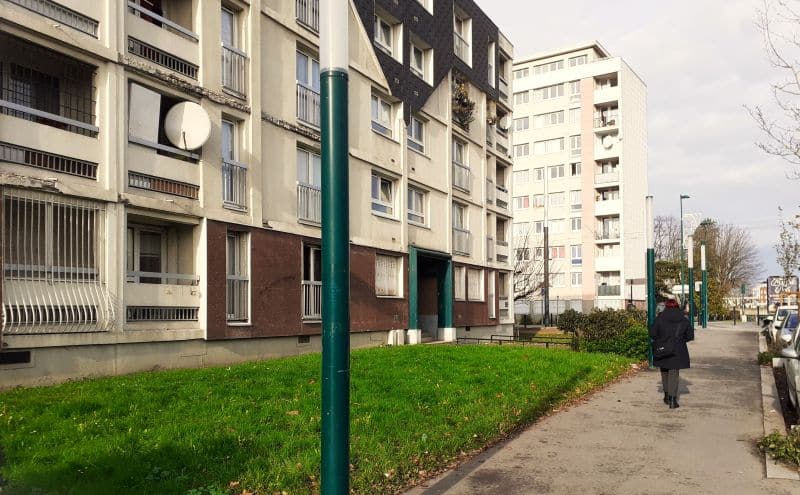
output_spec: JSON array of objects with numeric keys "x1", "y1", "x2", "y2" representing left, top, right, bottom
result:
[{"x1": 745, "y1": 0, "x2": 800, "y2": 172}]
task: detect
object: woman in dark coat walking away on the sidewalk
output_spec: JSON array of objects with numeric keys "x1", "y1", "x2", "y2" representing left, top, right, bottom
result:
[{"x1": 650, "y1": 299, "x2": 694, "y2": 409}]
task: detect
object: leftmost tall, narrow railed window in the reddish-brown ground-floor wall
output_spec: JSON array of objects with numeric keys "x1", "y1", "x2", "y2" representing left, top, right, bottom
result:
[{"x1": 225, "y1": 232, "x2": 250, "y2": 323}]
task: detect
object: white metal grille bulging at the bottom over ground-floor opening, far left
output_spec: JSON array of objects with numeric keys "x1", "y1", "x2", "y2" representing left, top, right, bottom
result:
[{"x1": 2, "y1": 189, "x2": 114, "y2": 334}]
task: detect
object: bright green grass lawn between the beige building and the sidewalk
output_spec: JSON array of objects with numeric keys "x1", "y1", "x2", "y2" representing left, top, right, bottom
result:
[{"x1": 0, "y1": 345, "x2": 631, "y2": 495}]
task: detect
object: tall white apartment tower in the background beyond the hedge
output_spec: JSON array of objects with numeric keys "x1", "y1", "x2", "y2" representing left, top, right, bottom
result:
[{"x1": 513, "y1": 42, "x2": 647, "y2": 313}]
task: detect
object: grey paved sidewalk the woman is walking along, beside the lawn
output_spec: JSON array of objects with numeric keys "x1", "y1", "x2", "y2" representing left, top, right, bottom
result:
[{"x1": 407, "y1": 322, "x2": 800, "y2": 495}]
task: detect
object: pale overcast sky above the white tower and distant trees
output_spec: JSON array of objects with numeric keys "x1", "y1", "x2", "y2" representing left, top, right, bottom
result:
[{"x1": 477, "y1": 0, "x2": 800, "y2": 275}]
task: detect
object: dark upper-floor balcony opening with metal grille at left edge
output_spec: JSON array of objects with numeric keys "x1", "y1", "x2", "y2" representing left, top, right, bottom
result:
[{"x1": 0, "y1": 34, "x2": 99, "y2": 136}]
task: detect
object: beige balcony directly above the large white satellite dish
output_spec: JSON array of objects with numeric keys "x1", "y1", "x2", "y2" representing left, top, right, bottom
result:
[{"x1": 126, "y1": 0, "x2": 200, "y2": 80}]
